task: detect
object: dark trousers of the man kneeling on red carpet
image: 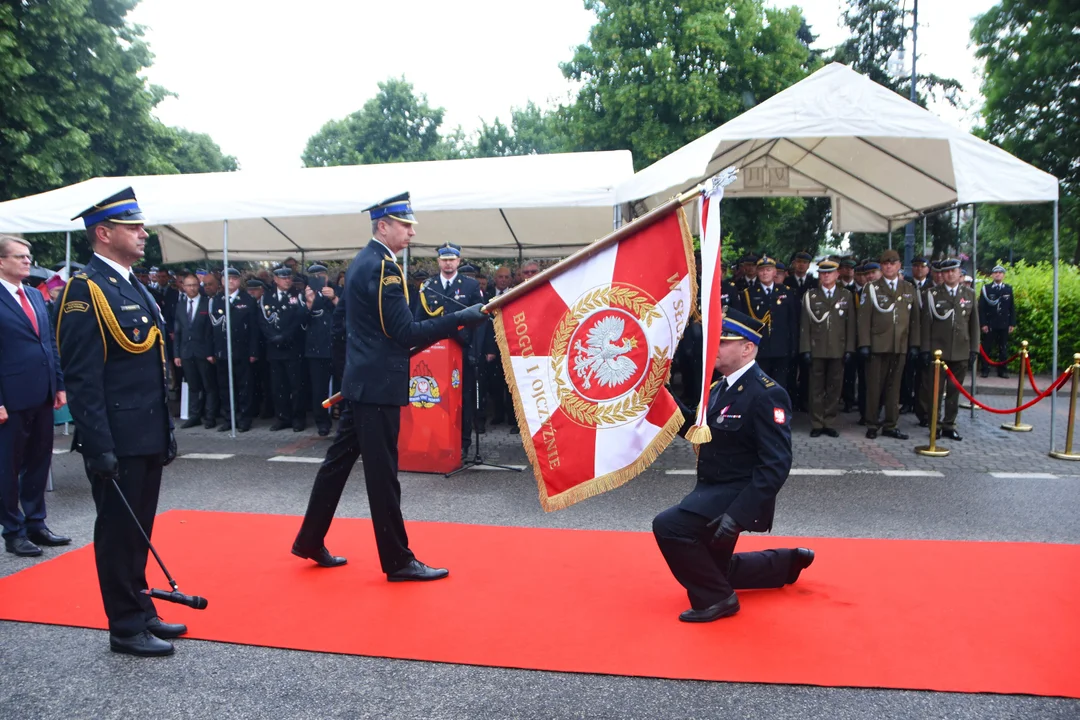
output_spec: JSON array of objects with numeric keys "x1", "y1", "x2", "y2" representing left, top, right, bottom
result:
[{"x1": 652, "y1": 506, "x2": 796, "y2": 610}]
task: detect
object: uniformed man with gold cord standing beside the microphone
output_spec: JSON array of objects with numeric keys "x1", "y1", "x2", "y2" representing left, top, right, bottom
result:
[{"x1": 56, "y1": 188, "x2": 180, "y2": 656}]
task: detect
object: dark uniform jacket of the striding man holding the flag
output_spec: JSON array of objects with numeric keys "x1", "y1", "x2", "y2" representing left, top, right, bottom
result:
[{"x1": 338, "y1": 239, "x2": 458, "y2": 406}]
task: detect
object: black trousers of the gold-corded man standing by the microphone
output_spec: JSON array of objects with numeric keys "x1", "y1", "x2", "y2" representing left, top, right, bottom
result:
[{"x1": 86, "y1": 454, "x2": 163, "y2": 637}]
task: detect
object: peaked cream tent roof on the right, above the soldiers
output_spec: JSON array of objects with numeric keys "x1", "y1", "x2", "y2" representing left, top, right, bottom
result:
[{"x1": 618, "y1": 63, "x2": 1057, "y2": 232}]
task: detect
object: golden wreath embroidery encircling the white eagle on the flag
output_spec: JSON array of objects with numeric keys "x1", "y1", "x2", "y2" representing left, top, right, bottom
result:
[{"x1": 551, "y1": 287, "x2": 669, "y2": 426}]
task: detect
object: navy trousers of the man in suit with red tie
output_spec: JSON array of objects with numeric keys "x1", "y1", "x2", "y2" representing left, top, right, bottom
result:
[{"x1": 0, "y1": 400, "x2": 53, "y2": 539}]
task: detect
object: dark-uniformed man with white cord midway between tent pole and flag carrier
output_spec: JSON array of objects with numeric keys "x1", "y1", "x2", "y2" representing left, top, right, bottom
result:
[{"x1": 259, "y1": 269, "x2": 308, "y2": 431}]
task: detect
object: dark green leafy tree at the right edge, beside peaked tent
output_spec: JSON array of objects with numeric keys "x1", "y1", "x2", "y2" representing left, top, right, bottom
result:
[{"x1": 971, "y1": 0, "x2": 1080, "y2": 263}]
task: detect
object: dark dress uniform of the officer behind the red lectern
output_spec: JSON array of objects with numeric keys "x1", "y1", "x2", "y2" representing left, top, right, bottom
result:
[{"x1": 416, "y1": 259, "x2": 483, "y2": 456}]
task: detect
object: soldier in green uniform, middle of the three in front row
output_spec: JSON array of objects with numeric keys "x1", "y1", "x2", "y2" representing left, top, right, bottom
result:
[{"x1": 859, "y1": 250, "x2": 919, "y2": 440}]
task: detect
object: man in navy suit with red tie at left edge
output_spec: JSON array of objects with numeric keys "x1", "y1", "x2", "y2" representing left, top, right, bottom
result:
[{"x1": 0, "y1": 235, "x2": 71, "y2": 557}]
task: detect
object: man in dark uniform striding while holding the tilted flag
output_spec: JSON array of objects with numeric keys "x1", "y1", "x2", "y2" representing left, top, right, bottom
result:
[{"x1": 293, "y1": 193, "x2": 486, "y2": 582}]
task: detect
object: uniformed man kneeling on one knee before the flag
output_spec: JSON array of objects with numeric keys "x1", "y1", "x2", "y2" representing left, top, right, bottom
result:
[{"x1": 652, "y1": 310, "x2": 813, "y2": 623}]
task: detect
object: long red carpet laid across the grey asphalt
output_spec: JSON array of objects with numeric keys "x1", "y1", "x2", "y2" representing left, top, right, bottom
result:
[{"x1": 0, "y1": 511, "x2": 1080, "y2": 697}]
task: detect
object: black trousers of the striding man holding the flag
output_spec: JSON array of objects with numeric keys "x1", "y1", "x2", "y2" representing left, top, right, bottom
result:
[{"x1": 296, "y1": 400, "x2": 415, "y2": 573}]
